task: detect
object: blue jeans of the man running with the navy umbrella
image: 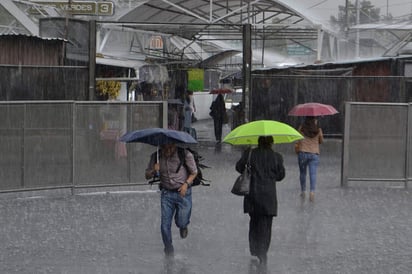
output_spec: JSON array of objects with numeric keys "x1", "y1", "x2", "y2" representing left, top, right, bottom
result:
[{"x1": 160, "y1": 188, "x2": 192, "y2": 251}]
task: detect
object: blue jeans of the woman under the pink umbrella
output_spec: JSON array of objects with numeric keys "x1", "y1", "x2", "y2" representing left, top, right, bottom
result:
[{"x1": 298, "y1": 152, "x2": 319, "y2": 192}]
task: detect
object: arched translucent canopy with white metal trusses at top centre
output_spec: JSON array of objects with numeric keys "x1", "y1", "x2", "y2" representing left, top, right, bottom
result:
[{"x1": 116, "y1": 0, "x2": 334, "y2": 40}]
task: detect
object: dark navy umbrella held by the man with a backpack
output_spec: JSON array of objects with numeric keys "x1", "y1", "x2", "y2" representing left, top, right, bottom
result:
[{"x1": 120, "y1": 128, "x2": 197, "y2": 146}]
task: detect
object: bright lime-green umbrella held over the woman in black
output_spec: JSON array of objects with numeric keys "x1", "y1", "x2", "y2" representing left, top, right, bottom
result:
[{"x1": 223, "y1": 120, "x2": 303, "y2": 145}]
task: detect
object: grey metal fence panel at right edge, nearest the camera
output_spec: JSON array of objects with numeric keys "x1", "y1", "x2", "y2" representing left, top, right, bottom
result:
[{"x1": 341, "y1": 102, "x2": 412, "y2": 187}]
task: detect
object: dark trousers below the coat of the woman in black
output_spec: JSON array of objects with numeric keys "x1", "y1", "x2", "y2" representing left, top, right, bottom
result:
[{"x1": 249, "y1": 214, "x2": 273, "y2": 259}]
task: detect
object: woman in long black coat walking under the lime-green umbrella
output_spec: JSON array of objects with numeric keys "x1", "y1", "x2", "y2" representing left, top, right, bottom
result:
[{"x1": 236, "y1": 136, "x2": 285, "y2": 265}]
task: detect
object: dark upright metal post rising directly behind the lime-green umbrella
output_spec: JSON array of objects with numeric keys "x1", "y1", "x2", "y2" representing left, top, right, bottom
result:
[{"x1": 242, "y1": 24, "x2": 252, "y2": 123}]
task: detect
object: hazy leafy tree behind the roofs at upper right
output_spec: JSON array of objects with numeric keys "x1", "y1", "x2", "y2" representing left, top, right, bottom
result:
[{"x1": 330, "y1": 0, "x2": 382, "y2": 31}]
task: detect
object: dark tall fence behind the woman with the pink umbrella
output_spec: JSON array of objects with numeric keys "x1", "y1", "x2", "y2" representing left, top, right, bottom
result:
[{"x1": 250, "y1": 75, "x2": 412, "y2": 137}]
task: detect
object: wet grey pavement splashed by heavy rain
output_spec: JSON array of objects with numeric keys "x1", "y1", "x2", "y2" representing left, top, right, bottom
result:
[{"x1": 0, "y1": 120, "x2": 412, "y2": 274}]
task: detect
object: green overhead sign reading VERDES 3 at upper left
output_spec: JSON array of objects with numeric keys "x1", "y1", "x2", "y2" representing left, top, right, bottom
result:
[{"x1": 29, "y1": 1, "x2": 113, "y2": 16}]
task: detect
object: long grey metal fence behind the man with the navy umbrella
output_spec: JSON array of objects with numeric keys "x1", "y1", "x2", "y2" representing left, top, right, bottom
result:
[{"x1": 0, "y1": 101, "x2": 167, "y2": 192}]
